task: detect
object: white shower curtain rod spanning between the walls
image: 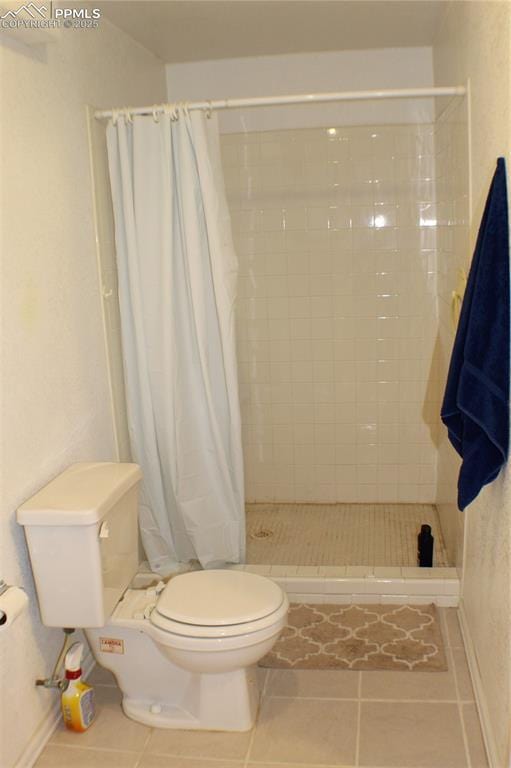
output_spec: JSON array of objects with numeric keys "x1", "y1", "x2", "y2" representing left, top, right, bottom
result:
[{"x1": 94, "y1": 85, "x2": 467, "y2": 120}]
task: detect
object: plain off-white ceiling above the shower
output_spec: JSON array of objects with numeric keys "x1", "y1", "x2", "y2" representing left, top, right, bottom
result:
[{"x1": 94, "y1": 0, "x2": 443, "y2": 63}]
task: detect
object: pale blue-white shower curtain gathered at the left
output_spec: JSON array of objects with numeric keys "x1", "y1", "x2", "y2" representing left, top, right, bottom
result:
[{"x1": 107, "y1": 106, "x2": 245, "y2": 575}]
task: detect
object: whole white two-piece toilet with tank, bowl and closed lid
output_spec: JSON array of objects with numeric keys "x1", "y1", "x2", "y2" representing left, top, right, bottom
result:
[{"x1": 17, "y1": 462, "x2": 288, "y2": 731}]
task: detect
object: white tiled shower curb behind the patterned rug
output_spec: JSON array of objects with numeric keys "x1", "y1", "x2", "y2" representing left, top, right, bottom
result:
[{"x1": 231, "y1": 564, "x2": 460, "y2": 608}]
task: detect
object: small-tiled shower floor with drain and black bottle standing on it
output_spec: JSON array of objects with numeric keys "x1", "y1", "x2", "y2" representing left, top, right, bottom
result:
[{"x1": 246, "y1": 503, "x2": 449, "y2": 567}]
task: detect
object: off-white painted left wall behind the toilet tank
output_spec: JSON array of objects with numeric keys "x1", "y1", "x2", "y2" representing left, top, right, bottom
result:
[{"x1": 0, "y1": 20, "x2": 165, "y2": 768}]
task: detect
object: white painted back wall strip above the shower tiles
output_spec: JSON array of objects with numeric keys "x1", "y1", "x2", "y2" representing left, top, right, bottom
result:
[{"x1": 167, "y1": 48, "x2": 434, "y2": 133}]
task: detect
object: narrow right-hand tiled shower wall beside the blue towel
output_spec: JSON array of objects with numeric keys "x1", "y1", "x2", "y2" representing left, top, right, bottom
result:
[{"x1": 435, "y1": 105, "x2": 471, "y2": 565}]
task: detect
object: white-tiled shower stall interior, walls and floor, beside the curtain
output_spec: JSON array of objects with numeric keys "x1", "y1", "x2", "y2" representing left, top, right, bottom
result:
[{"x1": 90, "y1": 87, "x2": 468, "y2": 584}]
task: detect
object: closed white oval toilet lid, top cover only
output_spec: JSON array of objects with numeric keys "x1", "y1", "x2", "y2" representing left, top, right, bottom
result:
[{"x1": 155, "y1": 570, "x2": 283, "y2": 627}]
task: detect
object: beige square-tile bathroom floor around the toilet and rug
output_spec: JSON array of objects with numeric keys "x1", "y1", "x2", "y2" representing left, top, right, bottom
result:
[{"x1": 36, "y1": 608, "x2": 488, "y2": 768}]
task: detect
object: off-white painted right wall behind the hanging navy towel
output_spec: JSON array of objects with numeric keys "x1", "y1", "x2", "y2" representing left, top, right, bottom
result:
[{"x1": 434, "y1": 2, "x2": 511, "y2": 768}]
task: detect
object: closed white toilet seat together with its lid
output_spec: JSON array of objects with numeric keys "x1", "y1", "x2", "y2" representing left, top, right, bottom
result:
[{"x1": 150, "y1": 570, "x2": 288, "y2": 638}]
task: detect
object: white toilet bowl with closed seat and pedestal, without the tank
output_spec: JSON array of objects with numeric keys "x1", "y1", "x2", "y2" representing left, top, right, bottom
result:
[{"x1": 85, "y1": 570, "x2": 289, "y2": 731}]
